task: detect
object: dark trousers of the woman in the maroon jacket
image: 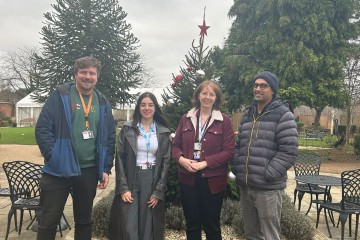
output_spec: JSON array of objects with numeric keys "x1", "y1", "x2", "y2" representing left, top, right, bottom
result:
[{"x1": 180, "y1": 173, "x2": 224, "y2": 240}]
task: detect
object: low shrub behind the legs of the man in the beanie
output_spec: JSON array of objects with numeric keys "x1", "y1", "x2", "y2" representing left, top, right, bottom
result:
[{"x1": 232, "y1": 194, "x2": 315, "y2": 240}]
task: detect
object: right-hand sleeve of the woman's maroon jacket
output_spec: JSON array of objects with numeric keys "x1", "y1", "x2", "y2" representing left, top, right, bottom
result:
[{"x1": 205, "y1": 116, "x2": 235, "y2": 169}]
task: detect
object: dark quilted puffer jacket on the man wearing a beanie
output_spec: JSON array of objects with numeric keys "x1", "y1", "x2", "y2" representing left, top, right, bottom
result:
[{"x1": 232, "y1": 97, "x2": 298, "y2": 190}]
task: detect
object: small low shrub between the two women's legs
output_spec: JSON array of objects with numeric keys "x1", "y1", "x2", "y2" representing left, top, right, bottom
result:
[{"x1": 165, "y1": 205, "x2": 186, "y2": 231}]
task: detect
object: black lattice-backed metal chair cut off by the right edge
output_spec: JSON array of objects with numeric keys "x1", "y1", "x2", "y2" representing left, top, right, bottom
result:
[{"x1": 316, "y1": 169, "x2": 360, "y2": 239}]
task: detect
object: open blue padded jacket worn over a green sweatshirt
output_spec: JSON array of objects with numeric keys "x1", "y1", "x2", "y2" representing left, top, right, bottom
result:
[{"x1": 35, "y1": 83, "x2": 116, "y2": 181}]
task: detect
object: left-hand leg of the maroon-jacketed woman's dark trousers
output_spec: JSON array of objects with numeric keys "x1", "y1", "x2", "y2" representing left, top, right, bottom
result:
[{"x1": 180, "y1": 175, "x2": 201, "y2": 240}]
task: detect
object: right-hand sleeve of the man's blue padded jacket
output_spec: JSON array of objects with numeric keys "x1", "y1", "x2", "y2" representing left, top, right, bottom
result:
[{"x1": 104, "y1": 101, "x2": 116, "y2": 174}]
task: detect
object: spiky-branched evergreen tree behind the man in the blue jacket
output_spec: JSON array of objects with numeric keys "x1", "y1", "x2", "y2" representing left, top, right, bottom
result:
[{"x1": 33, "y1": 0, "x2": 142, "y2": 105}]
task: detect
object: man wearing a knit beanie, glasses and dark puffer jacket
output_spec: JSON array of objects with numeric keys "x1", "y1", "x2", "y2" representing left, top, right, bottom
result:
[{"x1": 232, "y1": 71, "x2": 298, "y2": 240}]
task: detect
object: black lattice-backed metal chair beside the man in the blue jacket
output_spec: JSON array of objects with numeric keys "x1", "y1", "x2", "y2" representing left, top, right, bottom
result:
[{"x1": 3, "y1": 161, "x2": 69, "y2": 239}]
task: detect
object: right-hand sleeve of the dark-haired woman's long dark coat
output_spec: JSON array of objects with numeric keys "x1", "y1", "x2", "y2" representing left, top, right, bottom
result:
[{"x1": 152, "y1": 133, "x2": 171, "y2": 200}]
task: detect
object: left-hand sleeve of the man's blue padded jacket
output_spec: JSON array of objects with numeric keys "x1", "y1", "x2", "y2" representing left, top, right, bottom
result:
[{"x1": 35, "y1": 90, "x2": 60, "y2": 161}]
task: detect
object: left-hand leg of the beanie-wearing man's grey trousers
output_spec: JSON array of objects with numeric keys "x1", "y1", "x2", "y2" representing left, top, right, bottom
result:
[{"x1": 240, "y1": 188, "x2": 264, "y2": 240}]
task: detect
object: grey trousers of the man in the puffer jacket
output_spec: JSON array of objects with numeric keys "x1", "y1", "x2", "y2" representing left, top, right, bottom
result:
[{"x1": 240, "y1": 187, "x2": 284, "y2": 240}]
